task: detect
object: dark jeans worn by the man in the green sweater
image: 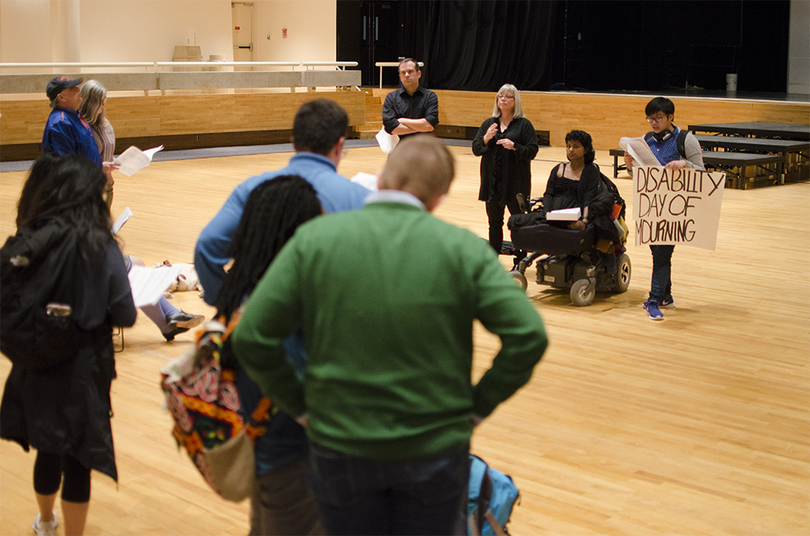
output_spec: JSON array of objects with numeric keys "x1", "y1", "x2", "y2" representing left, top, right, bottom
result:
[{"x1": 310, "y1": 444, "x2": 470, "y2": 535}]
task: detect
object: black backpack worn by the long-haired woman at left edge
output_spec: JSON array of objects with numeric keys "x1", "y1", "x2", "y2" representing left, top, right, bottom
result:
[{"x1": 0, "y1": 218, "x2": 79, "y2": 371}]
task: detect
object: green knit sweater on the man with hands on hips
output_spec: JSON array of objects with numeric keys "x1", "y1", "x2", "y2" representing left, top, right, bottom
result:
[{"x1": 232, "y1": 202, "x2": 547, "y2": 459}]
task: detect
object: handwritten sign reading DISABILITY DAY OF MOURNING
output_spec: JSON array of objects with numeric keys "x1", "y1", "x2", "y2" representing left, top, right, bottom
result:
[{"x1": 633, "y1": 166, "x2": 726, "y2": 249}]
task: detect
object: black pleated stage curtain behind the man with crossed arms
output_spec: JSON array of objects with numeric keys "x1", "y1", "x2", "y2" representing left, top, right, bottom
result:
[{"x1": 401, "y1": 0, "x2": 557, "y2": 91}]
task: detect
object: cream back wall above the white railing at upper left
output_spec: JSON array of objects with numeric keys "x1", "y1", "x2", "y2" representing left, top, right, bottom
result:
[{"x1": 0, "y1": 0, "x2": 337, "y2": 63}]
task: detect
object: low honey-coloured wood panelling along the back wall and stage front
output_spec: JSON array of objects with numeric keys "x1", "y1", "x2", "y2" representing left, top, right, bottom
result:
[{"x1": 0, "y1": 89, "x2": 810, "y2": 149}]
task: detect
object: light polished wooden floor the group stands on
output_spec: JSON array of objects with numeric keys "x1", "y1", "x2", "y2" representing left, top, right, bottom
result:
[{"x1": 0, "y1": 147, "x2": 810, "y2": 536}]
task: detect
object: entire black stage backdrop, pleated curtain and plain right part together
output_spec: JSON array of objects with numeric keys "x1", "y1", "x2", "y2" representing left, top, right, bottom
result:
[{"x1": 378, "y1": 0, "x2": 790, "y2": 92}]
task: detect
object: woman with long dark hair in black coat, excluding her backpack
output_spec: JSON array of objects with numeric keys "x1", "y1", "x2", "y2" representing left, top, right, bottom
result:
[{"x1": 0, "y1": 155, "x2": 136, "y2": 534}]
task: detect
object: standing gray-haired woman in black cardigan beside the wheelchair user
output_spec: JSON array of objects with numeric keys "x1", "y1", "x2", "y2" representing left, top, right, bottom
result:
[{"x1": 473, "y1": 84, "x2": 539, "y2": 253}]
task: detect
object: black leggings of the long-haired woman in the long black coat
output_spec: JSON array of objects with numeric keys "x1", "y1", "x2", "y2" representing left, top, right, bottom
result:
[{"x1": 34, "y1": 452, "x2": 90, "y2": 503}]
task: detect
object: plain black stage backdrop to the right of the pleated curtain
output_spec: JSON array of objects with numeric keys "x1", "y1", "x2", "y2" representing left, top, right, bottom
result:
[{"x1": 552, "y1": 0, "x2": 790, "y2": 92}]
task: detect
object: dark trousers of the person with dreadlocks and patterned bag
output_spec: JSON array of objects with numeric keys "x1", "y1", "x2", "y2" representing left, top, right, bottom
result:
[{"x1": 250, "y1": 456, "x2": 325, "y2": 536}]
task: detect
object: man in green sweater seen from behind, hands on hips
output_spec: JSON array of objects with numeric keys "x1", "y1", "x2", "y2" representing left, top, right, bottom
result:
[{"x1": 231, "y1": 135, "x2": 547, "y2": 534}]
